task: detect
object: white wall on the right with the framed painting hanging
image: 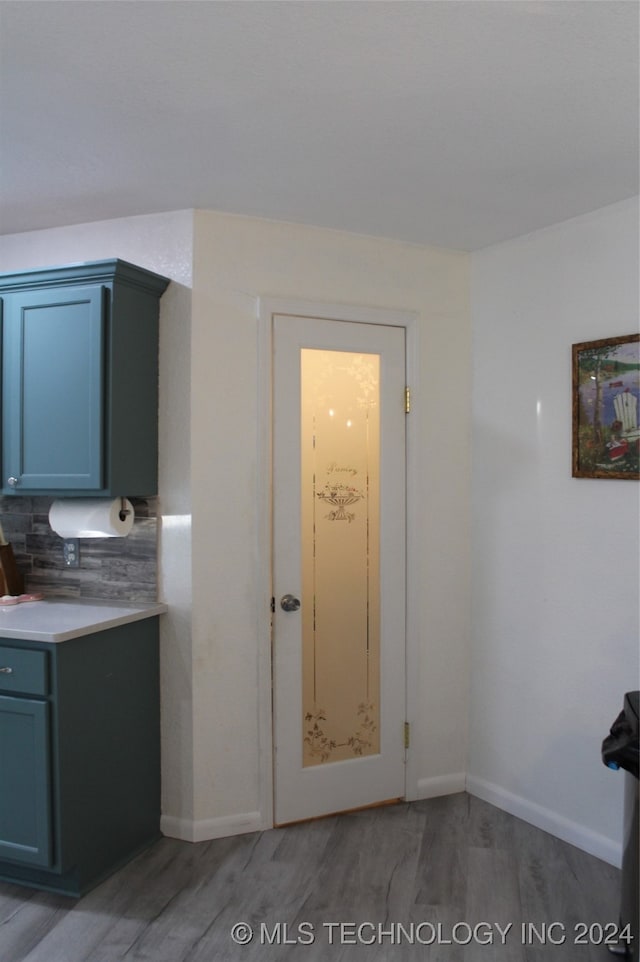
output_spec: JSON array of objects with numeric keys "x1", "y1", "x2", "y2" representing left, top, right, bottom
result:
[{"x1": 468, "y1": 201, "x2": 639, "y2": 862}]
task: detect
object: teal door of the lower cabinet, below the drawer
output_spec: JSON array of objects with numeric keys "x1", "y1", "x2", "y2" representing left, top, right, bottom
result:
[{"x1": 0, "y1": 695, "x2": 52, "y2": 867}]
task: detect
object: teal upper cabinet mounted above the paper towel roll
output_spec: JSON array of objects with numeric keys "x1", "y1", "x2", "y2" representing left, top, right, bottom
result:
[{"x1": 0, "y1": 260, "x2": 169, "y2": 497}]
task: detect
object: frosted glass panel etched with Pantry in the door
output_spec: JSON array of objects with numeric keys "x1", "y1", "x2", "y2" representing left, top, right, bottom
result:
[{"x1": 300, "y1": 348, "x2": 380, "y2": 767}]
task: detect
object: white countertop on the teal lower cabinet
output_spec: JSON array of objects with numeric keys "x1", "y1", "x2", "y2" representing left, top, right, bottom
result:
[{"x1": 0, "y1": 598, "x2": 167, "y2": 643}]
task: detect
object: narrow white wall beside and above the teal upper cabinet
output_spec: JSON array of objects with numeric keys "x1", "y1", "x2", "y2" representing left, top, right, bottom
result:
[{"x1": 0, "y1": 211, "x2": 193, "y2": 818}]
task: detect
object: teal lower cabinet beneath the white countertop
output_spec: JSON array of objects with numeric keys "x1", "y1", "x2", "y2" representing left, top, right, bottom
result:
[{"x1": 0, "y1": 617, "x2": 160, "y2": 897}]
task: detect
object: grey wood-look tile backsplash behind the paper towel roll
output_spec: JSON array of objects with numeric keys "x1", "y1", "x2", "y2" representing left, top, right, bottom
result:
[{"x1": 0, "y1": 496, "x2": 158, "y2": 602}]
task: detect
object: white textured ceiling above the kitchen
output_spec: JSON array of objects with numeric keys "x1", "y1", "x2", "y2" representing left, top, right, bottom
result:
[{"x1": 0, "y1": 0, "x2": 639, "y2": 250}]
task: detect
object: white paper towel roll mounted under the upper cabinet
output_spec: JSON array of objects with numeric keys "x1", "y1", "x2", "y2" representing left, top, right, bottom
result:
[{"x1": 49, "y1": 498, "x2": 134, "y2": 538}]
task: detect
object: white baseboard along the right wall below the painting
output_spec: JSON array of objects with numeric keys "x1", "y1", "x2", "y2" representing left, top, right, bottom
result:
[{"x1": 467, "y1": 775, "x2": 622, "y2": 868}]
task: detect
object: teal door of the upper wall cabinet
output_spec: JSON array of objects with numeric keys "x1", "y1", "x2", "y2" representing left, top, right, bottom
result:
[{"x1": 2, "y1": 286, "x2": 105, "y2": 493}]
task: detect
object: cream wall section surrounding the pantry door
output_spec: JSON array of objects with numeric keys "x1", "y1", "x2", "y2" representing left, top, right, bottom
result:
[{"x1": 192, "y1": 211, "x2": 470, "y2": 837}]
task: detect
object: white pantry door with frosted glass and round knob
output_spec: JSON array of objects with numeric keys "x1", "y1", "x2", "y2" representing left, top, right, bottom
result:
[{"x1": 273, "y1": 314, "x2": 406, "y2": 825}]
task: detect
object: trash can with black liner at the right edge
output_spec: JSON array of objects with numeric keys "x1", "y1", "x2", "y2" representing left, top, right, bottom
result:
[{"x1": 602, "y1": 691, "x2": 640, "y2": 962}]
